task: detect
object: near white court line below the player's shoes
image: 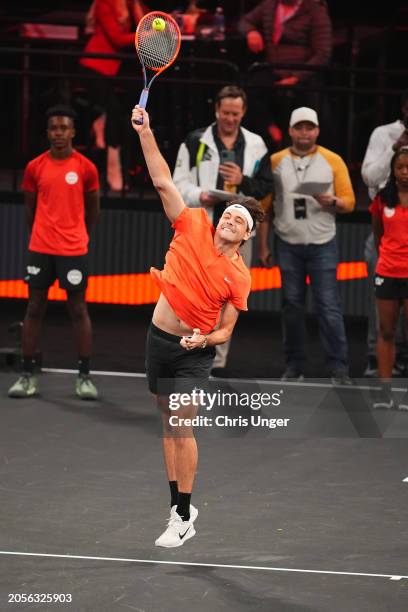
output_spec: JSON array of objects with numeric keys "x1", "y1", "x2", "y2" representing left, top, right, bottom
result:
[{"x1": 0, "y1": 550, "x2": 408, "y2": 580}]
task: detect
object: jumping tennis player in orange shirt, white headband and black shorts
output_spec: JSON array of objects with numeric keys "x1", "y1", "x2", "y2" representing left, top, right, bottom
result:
[{"x1": 132, "y1": 106, "x2": 263, "y2": 548}]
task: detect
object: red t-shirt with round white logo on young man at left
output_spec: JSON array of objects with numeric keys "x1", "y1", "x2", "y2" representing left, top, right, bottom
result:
[{"x1": 22, "y1": 150, "x2": 99, "y2": 255}]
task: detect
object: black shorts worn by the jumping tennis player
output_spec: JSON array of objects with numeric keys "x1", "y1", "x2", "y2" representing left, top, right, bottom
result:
[{"x1": 146, "y1": 323, "x2": 215, "y2": 396}]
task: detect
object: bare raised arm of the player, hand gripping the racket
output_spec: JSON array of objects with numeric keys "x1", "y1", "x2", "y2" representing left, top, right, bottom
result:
[{"x1": 132, "y1": 106, "x2": 185, "y2": 223}]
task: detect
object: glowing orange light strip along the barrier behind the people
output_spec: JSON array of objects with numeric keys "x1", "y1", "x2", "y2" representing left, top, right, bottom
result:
[{"x1": 0, "y1": 261, "x2": 367, "y2": 305}]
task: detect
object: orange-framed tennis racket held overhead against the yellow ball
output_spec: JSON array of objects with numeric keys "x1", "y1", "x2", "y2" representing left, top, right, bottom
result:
[{"x1": 135, "y1": 11, "x2": 181, "y2": 123}]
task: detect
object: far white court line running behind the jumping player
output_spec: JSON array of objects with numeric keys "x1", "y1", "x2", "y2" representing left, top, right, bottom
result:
[{"x1": 41, "y1": 368, "x2": 407, "y2": 392}]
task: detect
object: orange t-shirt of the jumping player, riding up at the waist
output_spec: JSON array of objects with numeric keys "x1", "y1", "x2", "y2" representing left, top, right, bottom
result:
[{"x1": 150, "y1": 207, "x2": 251, "y2": 334}]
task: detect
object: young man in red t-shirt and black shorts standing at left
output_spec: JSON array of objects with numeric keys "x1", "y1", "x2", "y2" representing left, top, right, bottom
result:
[{"x1": 9, "y1": 106, "x2": 99, "y2": 400}]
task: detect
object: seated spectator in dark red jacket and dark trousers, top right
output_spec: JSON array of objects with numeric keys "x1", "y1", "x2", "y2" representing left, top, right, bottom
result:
[{"x1": 239, "y1": 0, "x2": 332, "y2": 148}]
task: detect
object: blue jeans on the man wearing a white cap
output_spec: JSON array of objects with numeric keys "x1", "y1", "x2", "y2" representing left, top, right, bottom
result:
[{"x1": 275, "y1": 235, "x2": 348, "y2": 373}]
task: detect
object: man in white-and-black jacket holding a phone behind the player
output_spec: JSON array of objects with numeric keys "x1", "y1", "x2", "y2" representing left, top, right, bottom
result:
[{"x1": 173, "y1": 85, "x2": 272, "y2": 374}]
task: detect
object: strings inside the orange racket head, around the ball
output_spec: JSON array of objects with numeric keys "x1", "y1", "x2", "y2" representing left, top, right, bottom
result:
[{"x1": 136, "y1": 14, "x2": 179, "y2": 70}]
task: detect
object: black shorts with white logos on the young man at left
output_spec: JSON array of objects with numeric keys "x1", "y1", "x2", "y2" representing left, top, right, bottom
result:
[{"x1": 24, "y1": 251, "x2": 88, "y2": 292}]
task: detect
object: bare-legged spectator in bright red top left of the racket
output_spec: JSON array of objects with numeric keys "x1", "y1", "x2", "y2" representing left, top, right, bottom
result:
[{"x1": 80, "y1": 0, "x2": 147, "y2": 191}]
